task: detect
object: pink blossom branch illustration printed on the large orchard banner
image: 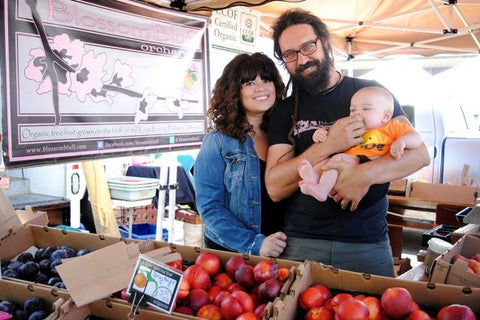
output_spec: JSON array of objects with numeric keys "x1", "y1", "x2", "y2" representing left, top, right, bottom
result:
[{"x1": 24, "y1": 0, "x2": 198, "y2": 125}]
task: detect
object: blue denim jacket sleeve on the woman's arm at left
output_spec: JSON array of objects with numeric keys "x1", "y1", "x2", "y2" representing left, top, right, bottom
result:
[{"x1": 195, "y1": 134, "x2": 265, "y2": 255}]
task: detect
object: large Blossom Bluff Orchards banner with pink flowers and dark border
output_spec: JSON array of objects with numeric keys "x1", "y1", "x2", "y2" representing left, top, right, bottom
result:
[{"x1": 0, "y1": 0, "x2": 209, "y2": 167}]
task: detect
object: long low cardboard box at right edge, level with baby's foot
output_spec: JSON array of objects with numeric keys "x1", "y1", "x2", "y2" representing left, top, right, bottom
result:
[{"x1": 410, "y1": 182, "x2": 480, "y2": 207}]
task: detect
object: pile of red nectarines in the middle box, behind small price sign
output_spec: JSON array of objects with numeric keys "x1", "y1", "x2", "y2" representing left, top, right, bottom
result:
[{"x1": 174, "y1": 252, "x2": 289, "y2": 320}]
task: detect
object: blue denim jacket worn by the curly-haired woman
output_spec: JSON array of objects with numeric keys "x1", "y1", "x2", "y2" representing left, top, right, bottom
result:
[{"x1": 195, "y1": 130, "x2": 265, "y2": 255}]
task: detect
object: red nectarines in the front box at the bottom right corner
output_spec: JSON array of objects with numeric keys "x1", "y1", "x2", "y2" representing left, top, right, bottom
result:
[{"x1": 298, "y1": 284, "x2": 476, "y2": 320}]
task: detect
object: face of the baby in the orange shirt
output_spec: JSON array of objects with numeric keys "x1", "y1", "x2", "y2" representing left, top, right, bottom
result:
[{"x1": 350, "y1": 91, "x2": 388, "y2": 130}]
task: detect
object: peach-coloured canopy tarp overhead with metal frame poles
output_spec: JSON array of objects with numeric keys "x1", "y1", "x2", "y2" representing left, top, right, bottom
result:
[{"x1": 144, "y1": 0, "x2": 480, "y2": 58}]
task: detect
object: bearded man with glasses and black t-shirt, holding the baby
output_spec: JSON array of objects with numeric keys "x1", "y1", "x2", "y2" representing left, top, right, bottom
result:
[{"x1": 266, "y1": 9, "x2": 430, "y2": 276}]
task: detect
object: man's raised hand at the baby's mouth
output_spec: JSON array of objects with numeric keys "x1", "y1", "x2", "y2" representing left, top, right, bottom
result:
[{"x1": 326, "y1": 115, "x2": 365, "y2": 153}]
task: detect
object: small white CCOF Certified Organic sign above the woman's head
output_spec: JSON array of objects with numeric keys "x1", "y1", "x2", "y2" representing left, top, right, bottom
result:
[{"x1": 209, "y1": 7, "x2": 260, "y2": 52}]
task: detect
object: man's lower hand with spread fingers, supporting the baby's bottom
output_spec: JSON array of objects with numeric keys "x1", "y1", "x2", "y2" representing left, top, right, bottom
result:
[{"x1": 322, "y1": 161, "x2": 370, "y2": 211}]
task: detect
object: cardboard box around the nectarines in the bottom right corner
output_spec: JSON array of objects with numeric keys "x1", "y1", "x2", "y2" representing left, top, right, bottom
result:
[{"x1": 271, "y1": 261, "x2": 480, "y2": 320}]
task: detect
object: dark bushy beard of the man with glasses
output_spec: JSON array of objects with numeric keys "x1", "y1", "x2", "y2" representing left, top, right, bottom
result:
[{"x1": 293, "y1": 58, "x2": 331, "y2": 96}]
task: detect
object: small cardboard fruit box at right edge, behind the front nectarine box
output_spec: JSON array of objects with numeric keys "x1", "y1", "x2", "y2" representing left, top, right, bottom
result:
[{"x1": 429, "y1": 235, "x2": 480, "y2": 288}]
